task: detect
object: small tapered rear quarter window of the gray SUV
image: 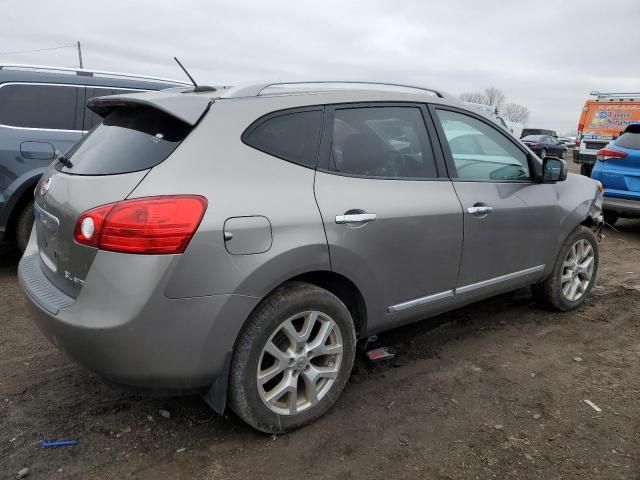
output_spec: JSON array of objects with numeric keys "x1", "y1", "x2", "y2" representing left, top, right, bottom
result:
[{"x1": 243, "y1": 110, "x2": 322, "y2": 168}]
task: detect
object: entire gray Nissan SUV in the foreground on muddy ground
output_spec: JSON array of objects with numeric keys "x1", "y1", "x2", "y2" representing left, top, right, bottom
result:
[{"x1": 19, "y1": 82, "x2": 602, "y2": 432}]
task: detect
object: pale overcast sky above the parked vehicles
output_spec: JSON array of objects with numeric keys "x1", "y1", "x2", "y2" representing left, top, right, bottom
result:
[{"x1": 0, "y1": 0, "x2": 640, "y2": 133}]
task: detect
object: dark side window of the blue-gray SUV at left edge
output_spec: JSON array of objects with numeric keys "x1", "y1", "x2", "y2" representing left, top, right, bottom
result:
[{"x1": 0, "y1": 84, "x2": 79, "y2": 130}]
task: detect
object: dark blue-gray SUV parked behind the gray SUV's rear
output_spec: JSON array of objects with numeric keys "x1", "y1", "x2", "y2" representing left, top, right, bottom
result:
[{"x1": 0, "y1": 65, "x2": 190, "y2": 250}]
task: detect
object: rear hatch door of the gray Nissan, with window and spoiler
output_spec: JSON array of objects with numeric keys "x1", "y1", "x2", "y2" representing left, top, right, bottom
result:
[{"x1": 34, "y1": 92, "x2": 211, "y2": 297}]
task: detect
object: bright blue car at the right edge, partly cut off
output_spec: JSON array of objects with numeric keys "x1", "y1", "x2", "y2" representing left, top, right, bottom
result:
[{"x1": 591, "y1": 123, "x2": 640, "y2": 225}]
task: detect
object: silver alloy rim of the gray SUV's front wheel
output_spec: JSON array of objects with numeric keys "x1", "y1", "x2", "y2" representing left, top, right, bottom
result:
[{"x1": 561, "y1": 239, "x2": 595, "y2": 302}]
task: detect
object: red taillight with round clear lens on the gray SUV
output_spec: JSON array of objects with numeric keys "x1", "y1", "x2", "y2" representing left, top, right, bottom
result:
[{"x1": 74, "y1": 195, "x2": 207, "y2": 254}]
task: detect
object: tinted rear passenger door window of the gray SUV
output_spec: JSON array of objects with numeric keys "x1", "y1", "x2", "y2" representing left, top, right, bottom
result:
[{"x1": 329, "y1": 107, "x2": 437, "y2": 178}]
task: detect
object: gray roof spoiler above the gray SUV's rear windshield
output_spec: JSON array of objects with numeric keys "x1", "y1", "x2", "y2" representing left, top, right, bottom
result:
[{"x1": 87, "y1": 89, "x2": 213, "y2": 126}]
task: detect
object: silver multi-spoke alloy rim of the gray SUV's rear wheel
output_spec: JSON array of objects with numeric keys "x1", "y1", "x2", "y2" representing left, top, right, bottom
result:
[{"x1": 257, "y1": 311, "x2": 343, "y2": 415}]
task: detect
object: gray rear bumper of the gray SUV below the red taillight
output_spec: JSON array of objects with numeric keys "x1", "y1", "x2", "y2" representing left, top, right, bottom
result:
[{"x1": 18, "y1": 252, "x2": 258, "y2": 393}]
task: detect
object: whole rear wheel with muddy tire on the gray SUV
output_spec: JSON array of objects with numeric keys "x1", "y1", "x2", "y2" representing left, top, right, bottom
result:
[{"x1": 229, "y1": 282, "x2": 356, "y2": 433}]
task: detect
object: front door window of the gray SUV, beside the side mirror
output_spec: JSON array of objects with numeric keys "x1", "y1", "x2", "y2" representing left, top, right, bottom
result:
[{"x1": 437, "y1": 110, "x2": 531, "y2": 182}]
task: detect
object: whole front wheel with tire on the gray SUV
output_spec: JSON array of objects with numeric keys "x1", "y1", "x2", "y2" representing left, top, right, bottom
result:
[{"x1": 532, "y1": 225, "x2": 599, "y2": 312}]
